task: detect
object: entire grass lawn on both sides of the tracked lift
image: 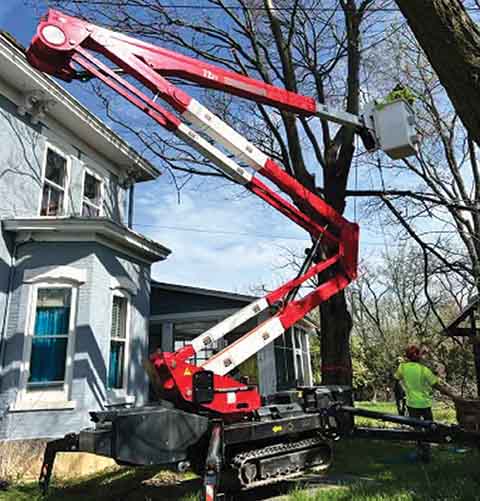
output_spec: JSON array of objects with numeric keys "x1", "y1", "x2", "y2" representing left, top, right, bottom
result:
[{"x1": 0, "y1": 402, "x2": 480, "y2": 501}]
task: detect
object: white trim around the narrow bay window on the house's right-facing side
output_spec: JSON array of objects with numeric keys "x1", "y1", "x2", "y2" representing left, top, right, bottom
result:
[{"x1": 105, "y1": 288, "x2": 135, "y2": 400}]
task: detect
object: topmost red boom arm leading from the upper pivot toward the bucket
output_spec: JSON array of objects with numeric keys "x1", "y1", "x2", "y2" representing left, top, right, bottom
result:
[{"x1": 29, "y1": 9, "x2": 316, "y2": 116}]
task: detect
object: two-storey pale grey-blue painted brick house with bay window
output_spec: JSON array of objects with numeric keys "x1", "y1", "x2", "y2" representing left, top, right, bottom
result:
[{"x1": 0, "y1": 34, "x2": 170, "y2": 439}]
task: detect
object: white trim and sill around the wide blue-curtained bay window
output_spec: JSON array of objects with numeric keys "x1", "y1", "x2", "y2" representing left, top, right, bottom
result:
[{"x1": 10, "y1": 280, "x2": 78, "y2": 411}]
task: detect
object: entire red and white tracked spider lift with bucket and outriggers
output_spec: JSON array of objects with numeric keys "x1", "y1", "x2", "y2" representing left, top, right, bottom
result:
[{"x1": 27, "y1": 10, "x2": 476, "y2": 501}]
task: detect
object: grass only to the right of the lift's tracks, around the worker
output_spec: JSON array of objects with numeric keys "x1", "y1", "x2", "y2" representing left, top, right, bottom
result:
[{"x1": 288, "y1": 402, "x2": 480, "y2": 501}]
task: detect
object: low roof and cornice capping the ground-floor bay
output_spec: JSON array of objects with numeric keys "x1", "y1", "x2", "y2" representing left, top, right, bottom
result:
[{"x1": 2, "y1": 216, "x2": 171, "y2": 263}]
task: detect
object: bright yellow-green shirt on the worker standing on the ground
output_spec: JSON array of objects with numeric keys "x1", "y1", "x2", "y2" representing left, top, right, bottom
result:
[{"x1": 394, "y1": 362, "x2": 438, "y2": 409}]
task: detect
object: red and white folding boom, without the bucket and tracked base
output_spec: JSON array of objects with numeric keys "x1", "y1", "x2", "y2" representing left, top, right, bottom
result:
[{"x1": 27, "y1": 10, "x2": 364, "y2": 418}]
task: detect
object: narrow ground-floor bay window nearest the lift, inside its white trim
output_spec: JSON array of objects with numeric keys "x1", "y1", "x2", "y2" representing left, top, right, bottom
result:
[{"x1": 107, "y1": 295, "x2": 128, "y2": 389}]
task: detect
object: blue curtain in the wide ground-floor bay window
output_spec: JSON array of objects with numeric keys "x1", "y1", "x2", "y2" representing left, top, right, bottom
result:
[{"x1": 29, "y1": 307, "x2": 70, "y2": 383}]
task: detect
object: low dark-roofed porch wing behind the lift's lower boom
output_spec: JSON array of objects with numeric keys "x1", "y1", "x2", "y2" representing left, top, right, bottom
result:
[{"x1": 150, "y1": 281, "x2": 315, "y2": 395}]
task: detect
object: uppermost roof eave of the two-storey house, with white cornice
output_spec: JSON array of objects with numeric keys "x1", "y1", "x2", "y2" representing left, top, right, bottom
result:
[{"x1": 0, "y1": 31, "x2": 160, "y2": 182}]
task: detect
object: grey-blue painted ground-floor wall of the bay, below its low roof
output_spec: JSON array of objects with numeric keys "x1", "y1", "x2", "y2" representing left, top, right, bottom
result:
[{"x1": 0, "y1": 243, "x2": 150, "y2": 439}]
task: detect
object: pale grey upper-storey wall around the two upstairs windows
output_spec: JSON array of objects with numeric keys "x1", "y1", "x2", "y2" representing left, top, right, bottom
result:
[{"x1": 0, "y1": 90, "x2": 127, "y2": 222}]
